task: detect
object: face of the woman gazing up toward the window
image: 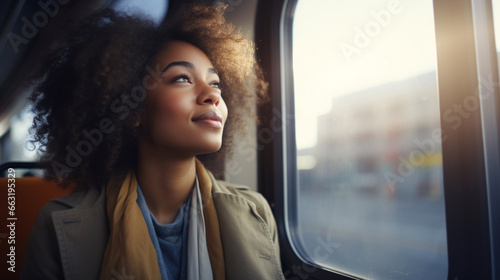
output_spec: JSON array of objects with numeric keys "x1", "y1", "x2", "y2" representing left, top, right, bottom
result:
[{"x1": 139, "y1": 41, "x2": 227, "y2": 156}]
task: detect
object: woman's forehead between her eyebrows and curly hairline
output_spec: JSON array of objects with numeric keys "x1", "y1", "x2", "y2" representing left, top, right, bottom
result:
[{"x1": 156, "y1": 41, "x2": 213, "y2": 69}]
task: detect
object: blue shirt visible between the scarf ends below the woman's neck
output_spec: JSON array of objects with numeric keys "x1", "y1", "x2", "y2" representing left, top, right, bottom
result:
[{"x1": 137, "y1": 185, "x2": 191, "y2": 280}]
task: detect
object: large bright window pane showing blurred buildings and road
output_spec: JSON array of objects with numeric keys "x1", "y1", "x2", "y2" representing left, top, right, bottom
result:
[{"x1": 285, "y1": 0, "x2": 448, "y2": 279}]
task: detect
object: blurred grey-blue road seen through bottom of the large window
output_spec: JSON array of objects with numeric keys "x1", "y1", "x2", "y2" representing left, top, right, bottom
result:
[{"x1": 297, "y1": 188, "x2": 448, "y2": 280}]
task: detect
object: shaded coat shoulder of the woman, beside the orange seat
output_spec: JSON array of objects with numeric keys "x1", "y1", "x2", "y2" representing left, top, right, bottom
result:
[{"x1": 21, "y1": 185, "x2": 107, "y2": 279}]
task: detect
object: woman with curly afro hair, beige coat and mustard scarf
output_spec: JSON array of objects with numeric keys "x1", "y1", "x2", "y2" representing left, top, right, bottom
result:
[{"x1": 22, "y1": 6, "x2": 284, "y2": 280}]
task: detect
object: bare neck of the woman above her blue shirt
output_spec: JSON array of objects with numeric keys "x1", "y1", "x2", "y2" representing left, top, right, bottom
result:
[{"x1": 137, "y1": 143, "x2": 196, "y2": 224}]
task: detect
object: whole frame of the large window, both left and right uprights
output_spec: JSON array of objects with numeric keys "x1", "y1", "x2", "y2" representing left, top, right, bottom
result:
[{"x1": 255, "y1": 0, "x2": 500, "y2": 279}]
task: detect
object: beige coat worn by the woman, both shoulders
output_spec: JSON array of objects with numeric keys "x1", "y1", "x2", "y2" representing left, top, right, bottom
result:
[{"x1": 21, "y1": 175, "x2": 285, "y2": 280}]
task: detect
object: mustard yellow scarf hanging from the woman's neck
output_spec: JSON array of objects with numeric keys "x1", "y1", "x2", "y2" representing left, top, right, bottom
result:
[{"x1": 100, "y1": 160, "x2": 226, "y2": 280}]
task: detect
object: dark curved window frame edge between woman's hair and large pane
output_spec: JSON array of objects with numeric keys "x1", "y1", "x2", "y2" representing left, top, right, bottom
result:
[{"x1": 255, "y1": 0, "x2": 362, "y2": 280}]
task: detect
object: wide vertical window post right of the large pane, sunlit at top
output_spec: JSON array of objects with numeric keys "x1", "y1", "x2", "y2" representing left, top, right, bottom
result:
[{"x1": 434, "y1": 0, "x2": 500, "y2": 279}]
